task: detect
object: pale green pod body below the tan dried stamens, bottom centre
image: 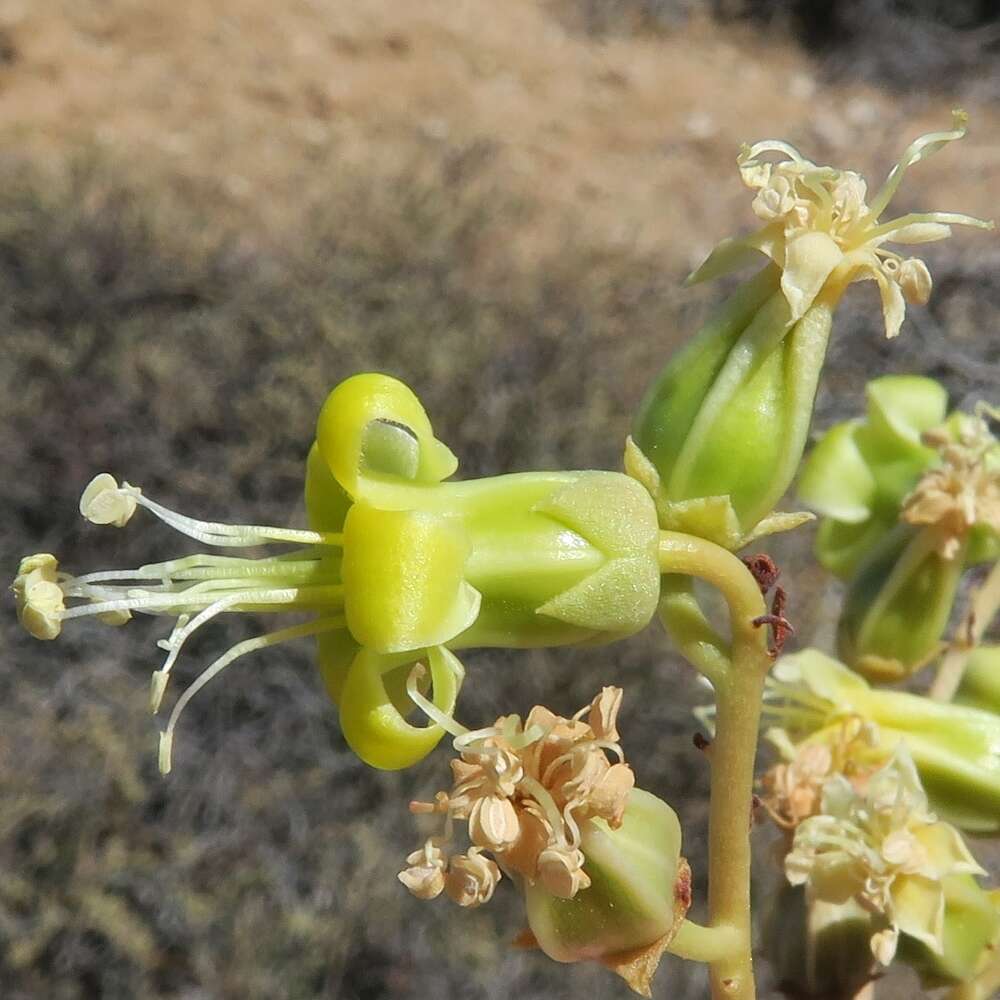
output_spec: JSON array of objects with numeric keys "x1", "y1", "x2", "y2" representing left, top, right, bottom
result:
[{"x1": 524, "y1": 789, "x2": 690, "y2": 996}]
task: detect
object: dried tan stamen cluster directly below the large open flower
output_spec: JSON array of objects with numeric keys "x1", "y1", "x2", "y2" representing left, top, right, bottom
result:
[{"x1": 399, "y1": 687, "x2": 635, "y2": 906}]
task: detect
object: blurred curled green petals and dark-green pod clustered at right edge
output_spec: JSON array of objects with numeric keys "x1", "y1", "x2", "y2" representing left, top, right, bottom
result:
[{"x1": 799, "y1": 375, "x2": 1000, "y2": 681}]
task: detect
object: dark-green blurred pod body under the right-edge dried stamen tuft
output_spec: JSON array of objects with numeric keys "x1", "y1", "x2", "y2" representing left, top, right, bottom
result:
[{"x1": 837, "y1": 524, "x2": 964, "y2": 682}]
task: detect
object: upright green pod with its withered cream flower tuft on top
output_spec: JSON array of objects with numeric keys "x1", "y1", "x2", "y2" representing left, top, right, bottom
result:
[{"x1": 631, "y1": 116, "x2": 992, "y2": 548}]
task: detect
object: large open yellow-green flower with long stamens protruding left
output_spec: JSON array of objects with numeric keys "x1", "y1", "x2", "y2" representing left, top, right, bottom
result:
[{"x1": 13, "y1": 374, "x2": 659, "y2": 771}]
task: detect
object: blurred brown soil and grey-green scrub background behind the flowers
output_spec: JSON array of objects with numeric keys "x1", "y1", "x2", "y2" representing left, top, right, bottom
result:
[{"x1": 0, "y1": 0, "x2": 1000, "y2": 1000}]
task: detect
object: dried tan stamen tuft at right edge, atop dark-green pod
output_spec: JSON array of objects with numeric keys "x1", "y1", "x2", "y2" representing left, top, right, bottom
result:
[{"x1": 902, "y1": 413, "x2": 1000, "y2": 559}]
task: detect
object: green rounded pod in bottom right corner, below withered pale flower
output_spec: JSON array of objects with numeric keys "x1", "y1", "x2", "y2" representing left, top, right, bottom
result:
[{"x1": 899, "y1": 875, "x2": 1000, "y2": 989}]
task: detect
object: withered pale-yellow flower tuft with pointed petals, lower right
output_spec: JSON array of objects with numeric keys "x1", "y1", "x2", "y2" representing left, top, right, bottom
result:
[{"x1": 785, "y1": 744, "x2": 986, "y2": 965}]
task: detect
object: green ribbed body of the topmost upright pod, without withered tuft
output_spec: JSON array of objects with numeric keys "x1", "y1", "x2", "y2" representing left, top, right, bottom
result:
[{"x1": 632, "y1": 267, "x2": 835, "y2": 548}]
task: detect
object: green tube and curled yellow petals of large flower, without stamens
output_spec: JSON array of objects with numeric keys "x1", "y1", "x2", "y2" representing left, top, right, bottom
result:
[{"x1": 306, "y1": 375, "x2": 659, "y2": 767}]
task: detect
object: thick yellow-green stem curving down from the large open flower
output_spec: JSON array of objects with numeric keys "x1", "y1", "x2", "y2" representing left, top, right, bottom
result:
[{"x1": 660, "y1": 531, "x2": 771, "y2": 1000}]
